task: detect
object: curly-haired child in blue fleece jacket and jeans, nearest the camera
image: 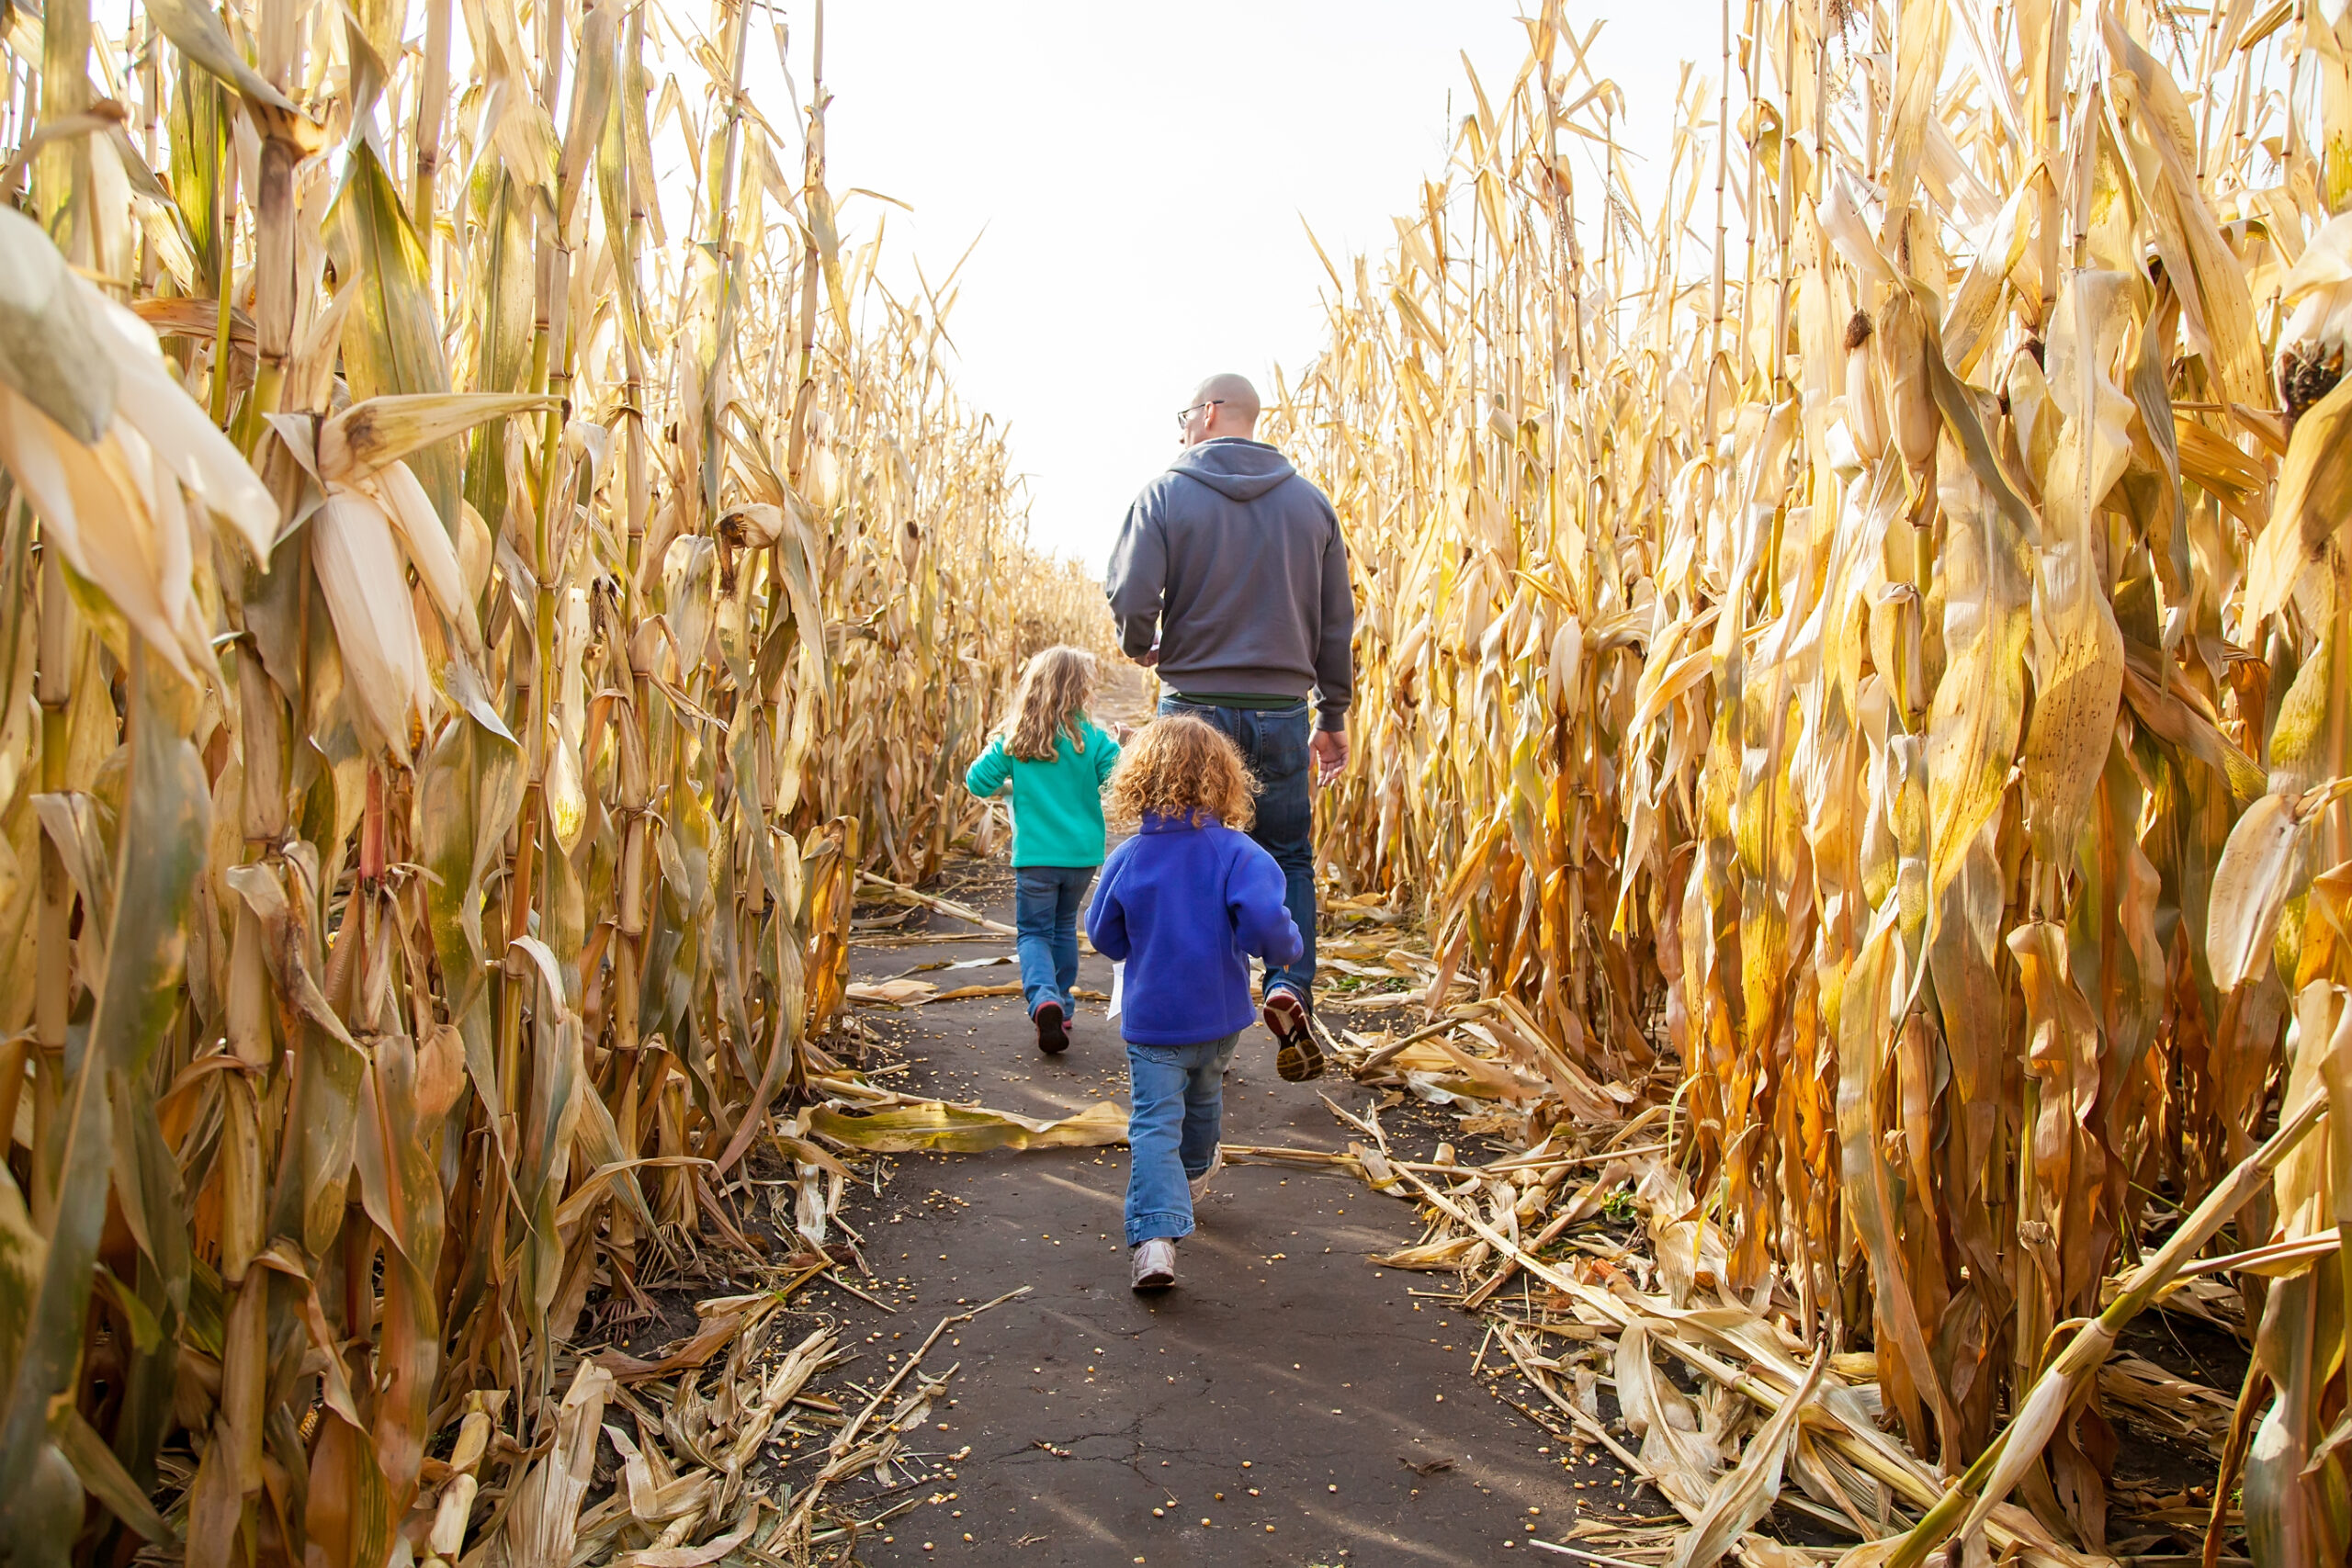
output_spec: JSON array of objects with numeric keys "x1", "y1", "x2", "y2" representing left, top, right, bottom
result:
[{"x1": 1087, "y1": 717, "x2": 1306, "y2": 1291}]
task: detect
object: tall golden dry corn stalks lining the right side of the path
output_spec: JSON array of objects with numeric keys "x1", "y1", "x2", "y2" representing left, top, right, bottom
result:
[{"x1": 1272, "y1": 0, "x2": 2352, "y2": 1568}]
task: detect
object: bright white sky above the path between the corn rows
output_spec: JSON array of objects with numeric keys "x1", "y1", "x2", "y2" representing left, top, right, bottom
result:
[{"x1": 780, "y1": 0, "x2": 1722, "y2": 569}]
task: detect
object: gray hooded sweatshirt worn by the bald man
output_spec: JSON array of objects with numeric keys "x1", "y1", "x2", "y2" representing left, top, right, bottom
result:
[{"x1": 1105, "y1": 437, "x2": 1355, "y2": 728}]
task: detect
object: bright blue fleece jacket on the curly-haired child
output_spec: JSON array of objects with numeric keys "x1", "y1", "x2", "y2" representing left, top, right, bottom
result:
[{"x1": 1087, "y1": 813, "x2": 1306, "y2": 1046}]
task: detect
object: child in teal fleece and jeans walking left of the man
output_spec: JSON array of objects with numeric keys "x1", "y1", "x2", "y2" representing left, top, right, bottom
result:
[{"x1": 965, "y1": 647, "x2": 1120, "y2": 1054}]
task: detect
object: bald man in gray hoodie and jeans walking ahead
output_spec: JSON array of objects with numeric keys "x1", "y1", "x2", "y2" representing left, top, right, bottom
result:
[{"x1": 1105, "y1": 376, "x2": 1355, "y2": 1084}]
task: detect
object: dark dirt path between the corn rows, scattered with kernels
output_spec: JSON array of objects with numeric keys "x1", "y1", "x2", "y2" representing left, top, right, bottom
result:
[{"x1": 831, "y1": 872, "x2": 1654, "y2": 1568}]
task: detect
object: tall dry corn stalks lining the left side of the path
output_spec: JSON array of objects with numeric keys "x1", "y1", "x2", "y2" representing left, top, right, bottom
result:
[{"x1": 0, "y1": 0, "x2": 1101, "y2": 1568}]
